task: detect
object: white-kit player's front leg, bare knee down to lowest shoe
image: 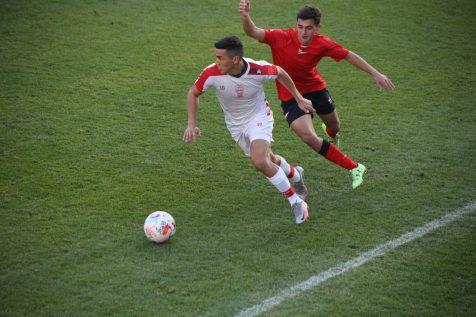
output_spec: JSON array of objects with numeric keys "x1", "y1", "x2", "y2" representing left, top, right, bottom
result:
[{"x1": 250, "y1": 139, "x2": 309, "y2": 223}]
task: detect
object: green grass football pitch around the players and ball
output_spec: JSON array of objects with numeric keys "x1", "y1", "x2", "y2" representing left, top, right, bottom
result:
[{"x1": 0, "y1": 0, "x2": 476, "y2": 316}]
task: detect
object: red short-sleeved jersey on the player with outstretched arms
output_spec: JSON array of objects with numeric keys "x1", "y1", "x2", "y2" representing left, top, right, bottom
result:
[{"x1": 263, "y1": 29, "x2": 349, "y2": 101}]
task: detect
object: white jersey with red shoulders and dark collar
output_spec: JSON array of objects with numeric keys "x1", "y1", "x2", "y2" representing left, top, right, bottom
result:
[{"x1": 195, "y1": 58, "x2": 278, "y2": 132}]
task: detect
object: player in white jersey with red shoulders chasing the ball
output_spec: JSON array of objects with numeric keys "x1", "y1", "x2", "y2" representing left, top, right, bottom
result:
[{"x1": 183, "y1": 36, "x2": 315, "y2": 224}]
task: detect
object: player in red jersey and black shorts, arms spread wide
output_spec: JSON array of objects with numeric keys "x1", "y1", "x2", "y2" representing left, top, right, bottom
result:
[{"x1": 239, "y1": 0, "x2": 394, "y2": 188}]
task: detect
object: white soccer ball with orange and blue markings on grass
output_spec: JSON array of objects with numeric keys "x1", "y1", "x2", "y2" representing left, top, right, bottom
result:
[{"x1": 144, "y1": 211, "x2": 176, "y2": 243}]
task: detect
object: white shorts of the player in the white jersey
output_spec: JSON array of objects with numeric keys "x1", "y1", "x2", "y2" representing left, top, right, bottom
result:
[{"x1": 229, "y1": 108, "x2": 274, "y2": 156}]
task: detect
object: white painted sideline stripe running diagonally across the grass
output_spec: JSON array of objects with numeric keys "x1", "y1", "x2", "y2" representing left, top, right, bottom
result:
[{"x1": 236, "y1": 201, "x2": 476, "y2": 317}]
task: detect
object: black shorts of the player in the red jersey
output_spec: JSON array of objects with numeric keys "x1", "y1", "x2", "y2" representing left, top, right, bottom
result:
[{"x1": 281, "y1": 89, "x2": 335, "y2": 125}]
